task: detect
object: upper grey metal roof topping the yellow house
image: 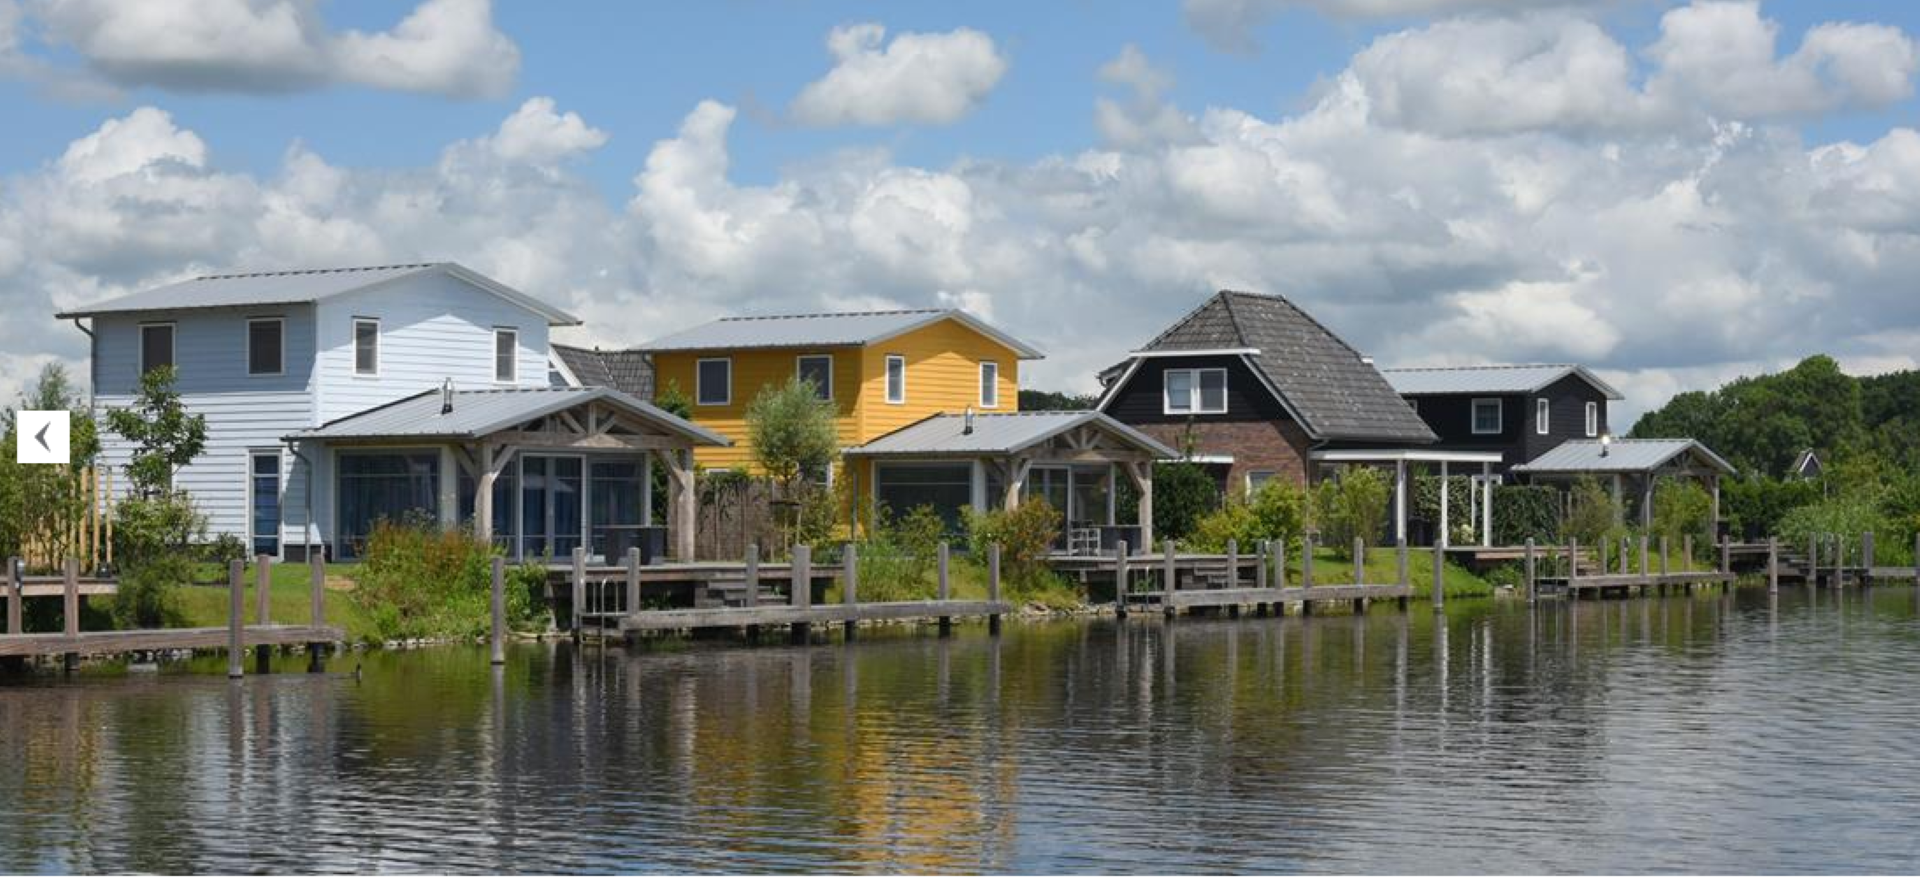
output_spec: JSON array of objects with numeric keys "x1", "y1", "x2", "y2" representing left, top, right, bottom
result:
[{"x1": 636, "y1": 309, "x2": 1044, "y2": 359}]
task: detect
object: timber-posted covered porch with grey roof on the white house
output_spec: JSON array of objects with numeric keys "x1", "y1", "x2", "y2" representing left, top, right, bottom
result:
[{"x1": 288, "y1": 388, "x2": 726, "y2": 559}]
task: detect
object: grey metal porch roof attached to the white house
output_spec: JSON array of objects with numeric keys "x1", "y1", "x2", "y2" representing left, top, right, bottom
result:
[{"x1": 282, "y1": 388, "x2": 732, "y2": 446}]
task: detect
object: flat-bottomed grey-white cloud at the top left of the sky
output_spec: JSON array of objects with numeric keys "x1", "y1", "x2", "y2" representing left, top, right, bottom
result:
[{"x1": 13, "y1": 0, "x2": 520, "y2": 98}]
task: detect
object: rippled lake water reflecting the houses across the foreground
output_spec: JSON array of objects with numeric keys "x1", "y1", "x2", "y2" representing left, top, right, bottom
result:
[{"x1": 0, "y1": 588, "x2": 1920, "y2": 872}]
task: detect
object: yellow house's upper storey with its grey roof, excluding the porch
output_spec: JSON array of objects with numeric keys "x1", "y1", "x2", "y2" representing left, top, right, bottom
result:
[{"x1": 637, "y1": 309, "x2": 1043, "y2": 471}]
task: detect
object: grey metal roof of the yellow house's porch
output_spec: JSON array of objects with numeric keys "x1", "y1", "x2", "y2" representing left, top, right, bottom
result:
[{"x1": 847, "y1": 411, "x2": 1179, "y2": 459}]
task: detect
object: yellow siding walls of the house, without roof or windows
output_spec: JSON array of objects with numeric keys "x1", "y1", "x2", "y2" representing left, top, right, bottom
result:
[{"x1": 653, "y1": 321, "x2": 1020, "y2": 469}]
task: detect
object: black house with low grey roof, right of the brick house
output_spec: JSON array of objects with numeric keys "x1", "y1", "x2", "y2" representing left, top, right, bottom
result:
[{"x1": 1380, "y1": 363, "x2": 1620, "y2": 475}]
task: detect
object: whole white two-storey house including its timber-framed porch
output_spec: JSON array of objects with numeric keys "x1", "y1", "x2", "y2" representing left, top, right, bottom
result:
[{"x1": 60, "y1": 263, "x2": 724, "y2": 559}]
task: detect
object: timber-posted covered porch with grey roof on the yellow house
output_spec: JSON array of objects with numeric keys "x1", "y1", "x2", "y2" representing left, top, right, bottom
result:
[{"x1": 847, "y1": 411, "x2": 1177, "y2": 553}]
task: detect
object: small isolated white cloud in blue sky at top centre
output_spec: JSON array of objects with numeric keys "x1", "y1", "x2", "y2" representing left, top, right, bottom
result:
[{"x1": 789, "y1": 23, "x2": 1006, "y2": 125}]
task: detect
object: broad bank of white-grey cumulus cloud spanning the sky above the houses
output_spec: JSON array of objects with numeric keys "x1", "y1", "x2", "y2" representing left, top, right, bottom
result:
[{"x1": 0, "y1": 0, "x2": 1920, "y2": 428}]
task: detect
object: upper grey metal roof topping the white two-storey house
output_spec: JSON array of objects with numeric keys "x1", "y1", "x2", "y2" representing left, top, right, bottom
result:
[{"x1": 56, "y1": 263, "x2": 580, "y2": 325}]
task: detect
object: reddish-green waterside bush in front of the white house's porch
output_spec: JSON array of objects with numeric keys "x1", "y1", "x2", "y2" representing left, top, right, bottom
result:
[{"x1": 353, "y1": 523, "x2": 547, "y2": 640}]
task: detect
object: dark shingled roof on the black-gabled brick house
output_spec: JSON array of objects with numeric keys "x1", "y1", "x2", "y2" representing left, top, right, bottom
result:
[{"x1": 1142, "y1": 290, "x2": 1438, "y2": 444}]
